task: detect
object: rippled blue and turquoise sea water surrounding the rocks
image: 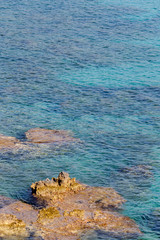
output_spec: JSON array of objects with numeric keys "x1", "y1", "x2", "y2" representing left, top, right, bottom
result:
[{"x1": 0, "y1": 0, "x2": 160, "y2": 240}]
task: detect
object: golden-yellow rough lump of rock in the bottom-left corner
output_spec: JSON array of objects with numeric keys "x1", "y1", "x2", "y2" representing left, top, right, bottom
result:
[{"x1": 0, "y1": 213, "x2": 28, "y2": 238}]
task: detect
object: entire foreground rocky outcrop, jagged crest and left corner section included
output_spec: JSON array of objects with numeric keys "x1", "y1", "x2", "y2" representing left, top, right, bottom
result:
[{"x1": 0, "y1": 172, "x2": 140, "y2": 240}]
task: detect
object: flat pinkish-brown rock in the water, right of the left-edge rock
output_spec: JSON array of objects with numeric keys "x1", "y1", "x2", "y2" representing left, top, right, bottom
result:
[{"x1": 25, "y1": 128, "x2": 76, "y2": 143}]
